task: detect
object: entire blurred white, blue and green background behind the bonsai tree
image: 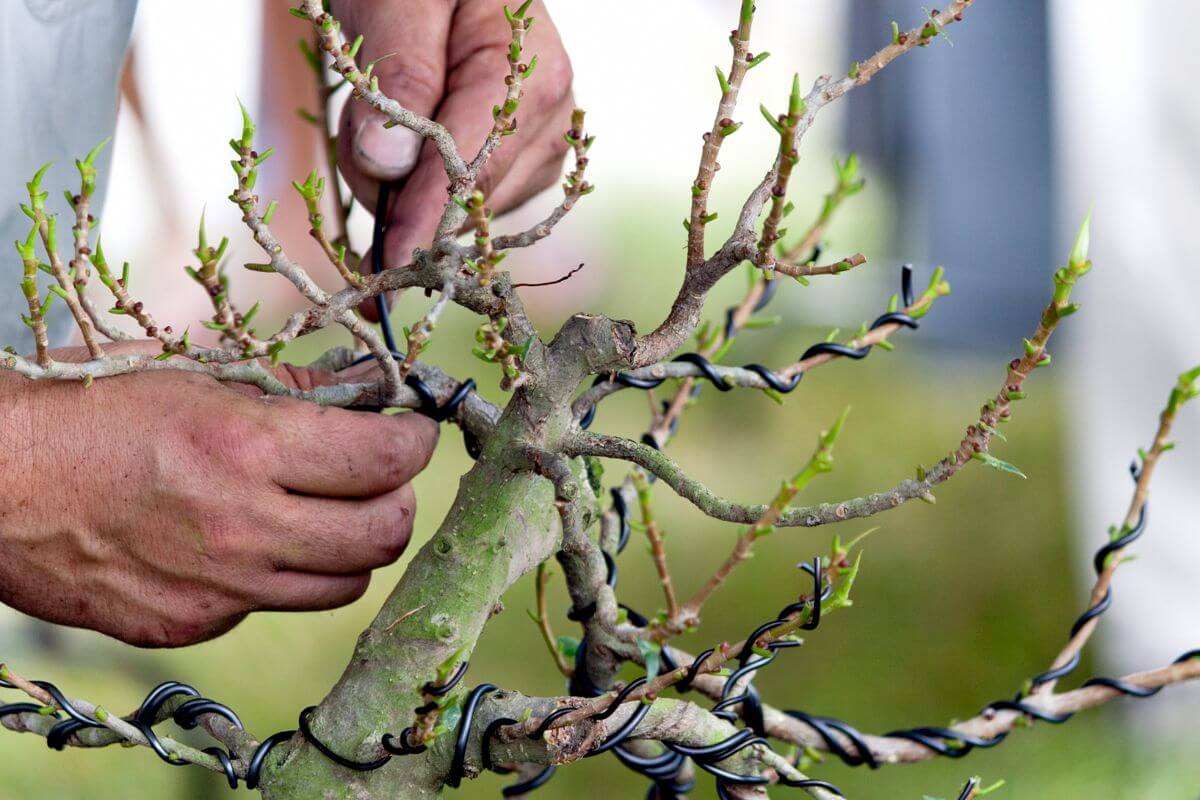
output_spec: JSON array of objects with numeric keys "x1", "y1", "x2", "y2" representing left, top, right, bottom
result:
[{"x1": 0, "y1": 0, "x2": 1200, "y2": 800}]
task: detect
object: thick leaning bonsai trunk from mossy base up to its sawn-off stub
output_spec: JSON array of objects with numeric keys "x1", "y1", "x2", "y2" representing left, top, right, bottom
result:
[{"x1": 263, "y1": 315, "x2": 634, "y2": 800}]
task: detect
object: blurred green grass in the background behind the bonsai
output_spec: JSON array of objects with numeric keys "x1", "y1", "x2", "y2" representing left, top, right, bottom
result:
[{"x1": 0, "y1": 183, "x2": 1200, "y2": 800}]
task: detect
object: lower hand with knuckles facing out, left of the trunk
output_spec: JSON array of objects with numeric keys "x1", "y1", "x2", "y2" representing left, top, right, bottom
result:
[{"x1": 0, "y1": 345, "x2": 438, "y2": 646}]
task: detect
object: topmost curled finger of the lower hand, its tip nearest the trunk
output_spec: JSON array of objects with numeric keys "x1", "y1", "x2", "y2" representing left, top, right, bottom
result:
[{"x1": 264, "y1": 397, "x2": 438, "y2": 498}]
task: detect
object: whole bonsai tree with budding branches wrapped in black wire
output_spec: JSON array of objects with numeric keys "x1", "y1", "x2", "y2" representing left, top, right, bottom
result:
[{"x1": 0, "y1": 0, "x2": 1200, "y2": 799}]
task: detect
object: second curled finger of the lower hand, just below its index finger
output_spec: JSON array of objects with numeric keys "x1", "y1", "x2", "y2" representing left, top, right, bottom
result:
[{"x1": 259, "y1": 486, "x2": 416, "y2": 575}]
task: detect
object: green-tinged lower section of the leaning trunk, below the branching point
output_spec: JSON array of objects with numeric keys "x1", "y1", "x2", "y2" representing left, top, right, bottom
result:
[{"x1": 263, "y1": 458, "x2": 559, "y2": 800}]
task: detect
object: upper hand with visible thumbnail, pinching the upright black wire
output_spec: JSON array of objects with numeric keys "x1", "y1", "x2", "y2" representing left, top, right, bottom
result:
[{"x1": 334, "y1": 0, "x2": 575, "y2": 286}]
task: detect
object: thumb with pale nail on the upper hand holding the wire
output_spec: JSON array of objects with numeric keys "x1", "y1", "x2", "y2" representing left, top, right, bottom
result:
[{"x1": 338, "y1": 7, "x2": 451, "y2": 190}]
